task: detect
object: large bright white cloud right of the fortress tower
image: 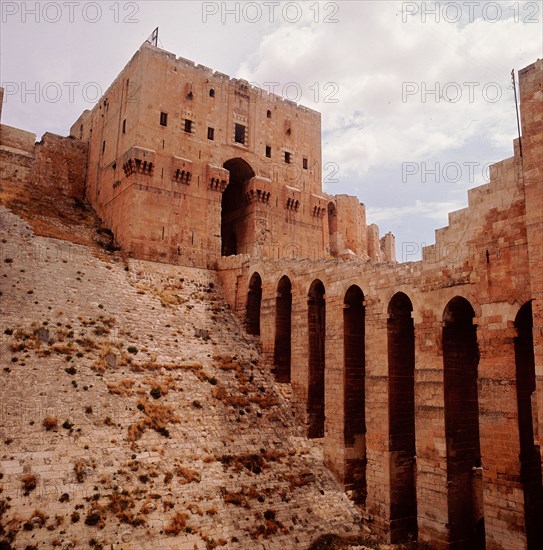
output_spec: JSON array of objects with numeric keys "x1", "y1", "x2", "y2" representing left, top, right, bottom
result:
[{"x1": 238, "y1": 2, "x2": 540, "y2": 176}]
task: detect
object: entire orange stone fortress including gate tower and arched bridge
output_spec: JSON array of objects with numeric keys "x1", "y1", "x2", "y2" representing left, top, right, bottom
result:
[{"x1": 0, "y1": 43, "x2": 543, "y2": 550}]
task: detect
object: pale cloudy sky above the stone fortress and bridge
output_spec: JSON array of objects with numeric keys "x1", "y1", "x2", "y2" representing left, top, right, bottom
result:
[{"x1": 0, "y1": 0, "x2": 543, "y2": 261}]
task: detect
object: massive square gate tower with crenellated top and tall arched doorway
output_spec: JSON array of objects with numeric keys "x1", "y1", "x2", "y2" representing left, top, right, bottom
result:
[{"x1": 70, "y1": 43, "x2": 394, "y2": 269}]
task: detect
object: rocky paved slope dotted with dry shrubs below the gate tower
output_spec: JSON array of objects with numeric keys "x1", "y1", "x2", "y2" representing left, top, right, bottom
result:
[{"x1": 0, "y1": 207, "x2": 370, "y2": 550}]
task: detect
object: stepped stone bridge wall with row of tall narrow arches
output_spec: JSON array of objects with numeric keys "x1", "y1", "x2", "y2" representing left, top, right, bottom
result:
[{"x1": 219, "y1": 61, "x2": 543, "y2": 549}]
